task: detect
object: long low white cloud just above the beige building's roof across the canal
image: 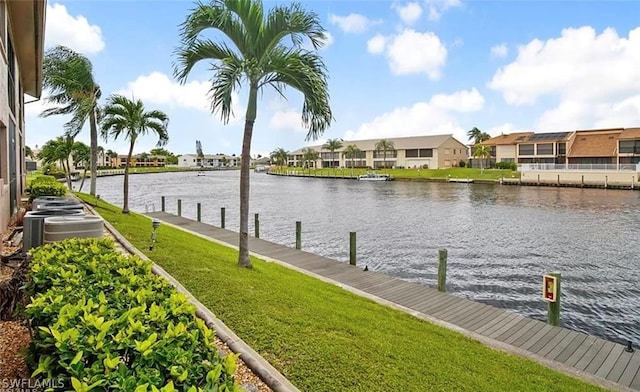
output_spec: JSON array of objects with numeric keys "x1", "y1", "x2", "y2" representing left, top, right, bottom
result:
[{"x1": 344, "y1": 89, "x2": 484, "y2": 143}]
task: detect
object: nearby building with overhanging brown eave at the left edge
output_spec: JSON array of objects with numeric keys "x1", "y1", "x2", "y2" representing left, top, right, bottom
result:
[{"x1": 0, "y1": 0, "x2": 46, "y2": 230}]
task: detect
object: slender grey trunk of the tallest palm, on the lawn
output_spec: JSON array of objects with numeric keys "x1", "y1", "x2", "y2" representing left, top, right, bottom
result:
[{"x1": 238, "y1": 83, "x2": 258, "y2": 268}]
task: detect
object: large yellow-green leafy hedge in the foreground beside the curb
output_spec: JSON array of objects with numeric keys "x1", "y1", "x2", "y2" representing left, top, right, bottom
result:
[{"x1": 26, "y1": 239, "x2": 239, "y2": 392}]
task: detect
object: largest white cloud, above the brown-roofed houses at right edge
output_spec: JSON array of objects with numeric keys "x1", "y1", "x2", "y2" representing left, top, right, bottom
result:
[{"x1": 489, "y1": 26, "x2": 640, "y2": 131}]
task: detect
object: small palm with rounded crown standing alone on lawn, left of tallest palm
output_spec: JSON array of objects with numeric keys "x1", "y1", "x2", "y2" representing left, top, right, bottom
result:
[{"x1": 102, "y1": 94, "x2": 169, "y2": 214}]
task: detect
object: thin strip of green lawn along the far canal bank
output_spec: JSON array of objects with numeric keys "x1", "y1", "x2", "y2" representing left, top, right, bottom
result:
[{"x1": 274, "y1": 167, "x2": 520, "y2": 181}]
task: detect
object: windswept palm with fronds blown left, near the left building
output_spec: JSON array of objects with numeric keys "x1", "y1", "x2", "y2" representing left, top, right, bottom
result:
[{"x1": 40, "y1": 46, "x2": 102, "y2": 195}]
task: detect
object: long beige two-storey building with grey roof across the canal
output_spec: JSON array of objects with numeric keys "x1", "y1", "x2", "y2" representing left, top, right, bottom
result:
[{"x1": 288, "y1": 135, "x2": 468, "y2": 169}]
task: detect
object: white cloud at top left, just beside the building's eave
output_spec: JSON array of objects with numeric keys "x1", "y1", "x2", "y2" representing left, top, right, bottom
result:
[{"x1": 45, "y1": 4, "x2": 105, "y2": 54}]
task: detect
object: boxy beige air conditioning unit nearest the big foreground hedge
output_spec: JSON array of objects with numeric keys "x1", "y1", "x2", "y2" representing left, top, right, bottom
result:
[{"x1": 43, "y1": 215, "x2": 104, "y2": 244}]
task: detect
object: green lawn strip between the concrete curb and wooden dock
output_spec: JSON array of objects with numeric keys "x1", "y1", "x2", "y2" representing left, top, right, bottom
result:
[{"x1": 79, "y1": 195, "x2": 600, "y2": 392}]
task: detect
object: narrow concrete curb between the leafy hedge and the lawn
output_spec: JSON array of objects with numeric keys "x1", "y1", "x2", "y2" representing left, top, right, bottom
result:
[{"x1": 83, "y1": 203, "x2": 300, "y2": 392}]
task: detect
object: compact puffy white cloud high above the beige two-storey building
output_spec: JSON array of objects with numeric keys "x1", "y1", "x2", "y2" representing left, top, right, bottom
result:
[{"x1": 367, "y1": 29, "x2": 447, "y2": 80}]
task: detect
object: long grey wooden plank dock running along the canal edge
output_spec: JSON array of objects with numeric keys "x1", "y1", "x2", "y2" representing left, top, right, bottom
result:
[{"x1": 146, "y1": 212, "x2": 640, "y2": 391}]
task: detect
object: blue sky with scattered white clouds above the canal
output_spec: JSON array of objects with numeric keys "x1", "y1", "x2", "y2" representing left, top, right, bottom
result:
[{"x1": 25, "y1": 0, "x2": 640, "y2": 155}]
